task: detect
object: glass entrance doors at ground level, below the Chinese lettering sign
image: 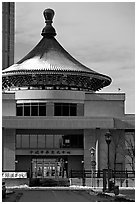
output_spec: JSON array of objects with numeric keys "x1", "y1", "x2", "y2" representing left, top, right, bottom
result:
[{"x1": 32, "y1": 158, "x2": 65, "y2": 178}]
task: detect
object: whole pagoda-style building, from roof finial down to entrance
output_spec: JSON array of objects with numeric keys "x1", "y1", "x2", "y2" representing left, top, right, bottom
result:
[{"x1": 2, "y1": 9, "x2": 135, "y2": 177}]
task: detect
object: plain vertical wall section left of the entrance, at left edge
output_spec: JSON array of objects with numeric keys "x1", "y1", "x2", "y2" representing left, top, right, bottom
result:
[{"x1": 2, "y1": 129, "x2": 15, "y2": 171}]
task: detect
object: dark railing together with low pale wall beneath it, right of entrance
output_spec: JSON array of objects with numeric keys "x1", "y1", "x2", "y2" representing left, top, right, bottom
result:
[{"x1": 69, "y1": 170, "x2": 135, "y2": 187}]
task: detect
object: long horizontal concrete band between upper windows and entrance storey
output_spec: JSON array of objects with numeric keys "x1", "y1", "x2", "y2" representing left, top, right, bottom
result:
[{"x1": 2, "y1": 116, "x2": 114, "y2": 130}]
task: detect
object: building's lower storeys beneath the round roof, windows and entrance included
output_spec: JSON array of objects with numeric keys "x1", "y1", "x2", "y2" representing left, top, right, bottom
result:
[{"x1": 2, "y1": 90, "x2": 135, "y2": 177}]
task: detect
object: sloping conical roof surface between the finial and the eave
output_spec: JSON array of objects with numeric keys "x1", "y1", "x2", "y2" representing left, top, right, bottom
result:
[{"x1": 2, "y1": 37, "x2": 111, "y2": 80}]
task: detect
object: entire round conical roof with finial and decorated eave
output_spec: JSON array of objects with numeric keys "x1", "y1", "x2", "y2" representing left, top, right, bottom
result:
[{"x1": 2, "y1": 9, "x2": 111, "y2": 91}]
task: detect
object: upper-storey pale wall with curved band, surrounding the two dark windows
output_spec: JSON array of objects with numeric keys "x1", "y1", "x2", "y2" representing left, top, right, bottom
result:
[{"x1": 3, "y1": 90, "x2": 125, "y2": 117}]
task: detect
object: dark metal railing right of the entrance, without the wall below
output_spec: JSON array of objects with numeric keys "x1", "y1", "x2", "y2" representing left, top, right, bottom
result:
[{"x1": 69, "y1": 170, "x2": 135, "y2": 178}]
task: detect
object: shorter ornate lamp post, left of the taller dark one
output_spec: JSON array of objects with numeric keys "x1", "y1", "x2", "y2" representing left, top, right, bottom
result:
[{"x1": 89, "y1": 147, "x2": 96, "y2": 187}]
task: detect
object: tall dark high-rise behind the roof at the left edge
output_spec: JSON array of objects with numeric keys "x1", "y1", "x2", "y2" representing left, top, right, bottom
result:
[{"x1": 2, "y1": 2, "x2": 15, "y2": 69}]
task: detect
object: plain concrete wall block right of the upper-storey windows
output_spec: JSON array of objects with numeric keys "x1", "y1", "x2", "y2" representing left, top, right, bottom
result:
[{"x1": 84, "y1": 93, "x2": 125, "y2": 117}]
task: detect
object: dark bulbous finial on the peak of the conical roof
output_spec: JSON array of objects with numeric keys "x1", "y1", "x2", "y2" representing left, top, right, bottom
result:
[{"x1": 41, "y1": 9, "x2": 56, "y2": 37}]
